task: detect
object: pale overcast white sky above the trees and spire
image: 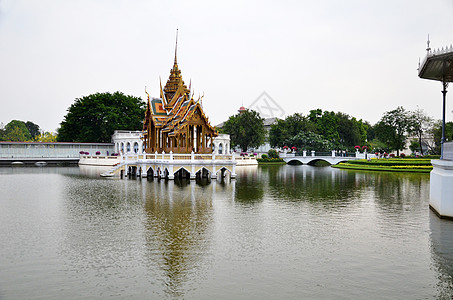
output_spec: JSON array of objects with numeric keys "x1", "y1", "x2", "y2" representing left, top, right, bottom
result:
[{"x1": 0, "y1": 0, "x2": 453, "y2": 131}]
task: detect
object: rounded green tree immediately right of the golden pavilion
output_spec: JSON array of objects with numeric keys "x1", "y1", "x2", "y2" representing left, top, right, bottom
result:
[{"x1": 222, "y1": 109, "x2": 266, "y2": 152}]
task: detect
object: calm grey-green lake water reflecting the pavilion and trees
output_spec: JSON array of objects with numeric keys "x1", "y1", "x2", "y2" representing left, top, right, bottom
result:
[{"x1": 0, "y1": 166, "x2": 453, "y2": 299}]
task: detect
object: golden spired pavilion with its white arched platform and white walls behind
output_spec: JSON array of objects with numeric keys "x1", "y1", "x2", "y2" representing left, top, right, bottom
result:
[{"x1": 101, "y1": 41, "x2": 237, "y2": 180}]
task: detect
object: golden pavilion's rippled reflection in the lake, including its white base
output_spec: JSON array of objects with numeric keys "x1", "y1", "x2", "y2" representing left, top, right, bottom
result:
[{"x1": 142, "y1": 179, "x2": 236, "y2": 297}]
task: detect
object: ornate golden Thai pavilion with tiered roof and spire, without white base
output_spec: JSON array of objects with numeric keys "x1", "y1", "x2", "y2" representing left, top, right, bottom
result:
[{"x1": 143, "y1": 51, "x2": 218, "y2": 153}]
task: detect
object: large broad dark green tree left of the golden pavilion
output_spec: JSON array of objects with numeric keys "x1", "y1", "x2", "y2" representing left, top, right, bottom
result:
[{"x1": 57, "y1": 92, "x2": 146, "y2": 143}]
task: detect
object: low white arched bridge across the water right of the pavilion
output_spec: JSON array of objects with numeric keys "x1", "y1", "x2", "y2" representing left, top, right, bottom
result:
[{"x1": 280, "y1": 150, "x2": 368, "y2": 165}]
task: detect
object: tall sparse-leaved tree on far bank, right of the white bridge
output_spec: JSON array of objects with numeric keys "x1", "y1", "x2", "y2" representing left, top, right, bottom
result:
[{"x1": 375, "y1": 106, "x2": 410, "y2": 156}]
